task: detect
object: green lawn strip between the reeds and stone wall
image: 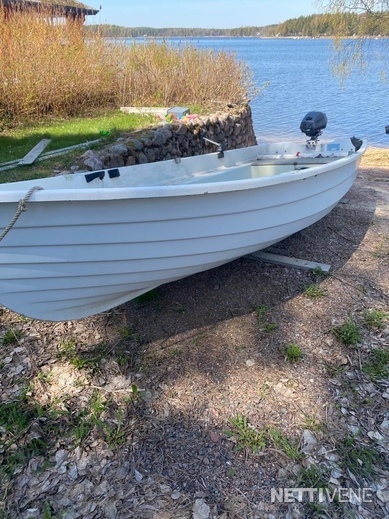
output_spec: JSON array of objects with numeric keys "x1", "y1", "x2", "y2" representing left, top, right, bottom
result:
[{"x1": 0, "y1": 110, "x2": 156, "y2": 167}]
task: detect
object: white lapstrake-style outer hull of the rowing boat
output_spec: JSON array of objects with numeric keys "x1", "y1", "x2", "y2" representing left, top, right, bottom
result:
[{"x1": 0, "y1": 140, "x2": 359, "y2": 321}]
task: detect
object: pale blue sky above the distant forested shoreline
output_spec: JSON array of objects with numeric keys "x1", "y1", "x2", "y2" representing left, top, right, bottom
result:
[{"x1": 90, "y1": 0, "x2": 319, "y2": 29}]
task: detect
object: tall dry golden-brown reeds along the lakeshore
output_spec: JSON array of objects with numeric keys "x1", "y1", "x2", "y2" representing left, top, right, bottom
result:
[{"x1": 0, "y1": 8, "x2": 254, "y2": 124}]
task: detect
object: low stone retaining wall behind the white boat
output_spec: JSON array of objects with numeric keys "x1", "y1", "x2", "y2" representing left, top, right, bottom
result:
[{"x1": 82, "y1": 105, "x2": 257, "y2": 170}]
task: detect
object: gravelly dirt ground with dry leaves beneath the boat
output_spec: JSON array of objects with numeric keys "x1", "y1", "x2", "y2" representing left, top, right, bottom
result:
[{"x1": 0, "y1": 149, "x2": 389, "y2": 519}]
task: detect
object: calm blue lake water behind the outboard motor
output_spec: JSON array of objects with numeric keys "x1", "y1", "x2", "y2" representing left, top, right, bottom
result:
[{"x1": 165, "y1": 38, "x2": 389, "y2": 147}]
